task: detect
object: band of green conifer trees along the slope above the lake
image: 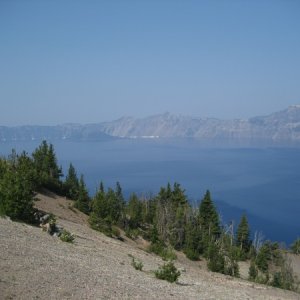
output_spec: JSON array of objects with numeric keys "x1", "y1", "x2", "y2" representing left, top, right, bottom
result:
[{"x1": 0, "y1": 141, "x2": 300, "y2": 290}]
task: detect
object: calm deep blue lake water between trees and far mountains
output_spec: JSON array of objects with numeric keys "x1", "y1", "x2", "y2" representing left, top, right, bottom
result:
[{"x1": 0, "y1": 139, "x2": 300, "y2": 244}]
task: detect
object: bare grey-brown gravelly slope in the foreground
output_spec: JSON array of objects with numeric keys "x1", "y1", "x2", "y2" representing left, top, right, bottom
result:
[{"x1": 0, "y1": 194, "x2": 300, "y2": 300}]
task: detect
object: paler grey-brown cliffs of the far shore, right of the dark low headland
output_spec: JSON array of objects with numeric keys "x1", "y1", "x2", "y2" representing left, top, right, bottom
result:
[{"x1": 101, "y1": 105, "x2": 300, "y2": 143}]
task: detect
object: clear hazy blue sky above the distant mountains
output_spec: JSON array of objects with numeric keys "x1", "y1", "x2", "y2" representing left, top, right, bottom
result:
[{"x1": 0, "y1": 0, "x2": 300, "y2": 125}]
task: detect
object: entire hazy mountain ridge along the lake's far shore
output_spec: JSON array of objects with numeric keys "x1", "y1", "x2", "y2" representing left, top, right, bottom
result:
[{"x1": 0, "y1": 105, "x2": 300, "y2": 145}]
